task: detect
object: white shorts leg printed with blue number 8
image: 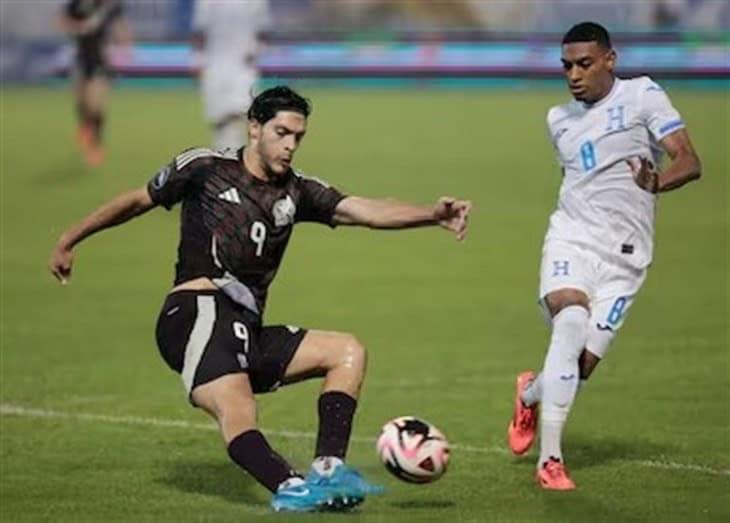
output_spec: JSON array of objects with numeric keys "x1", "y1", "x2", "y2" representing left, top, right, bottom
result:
[{"x1": 586, "y1": 266, "x2": 646, "y2": 359}]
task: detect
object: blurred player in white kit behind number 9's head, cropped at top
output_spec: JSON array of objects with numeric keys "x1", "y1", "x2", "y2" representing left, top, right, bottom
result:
[{"x1": 193, "y1": 0, "x2": 270, "y2": 150}]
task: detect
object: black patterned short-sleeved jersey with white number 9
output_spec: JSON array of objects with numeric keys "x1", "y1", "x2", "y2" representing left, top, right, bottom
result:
[{"x1": 147, "y1": 149, "x2": 344, "y2": 314}]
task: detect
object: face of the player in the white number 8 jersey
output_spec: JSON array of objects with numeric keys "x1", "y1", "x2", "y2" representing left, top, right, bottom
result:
[{"x1": 560, "y1": 42, "x2": 616, "y2": 103}]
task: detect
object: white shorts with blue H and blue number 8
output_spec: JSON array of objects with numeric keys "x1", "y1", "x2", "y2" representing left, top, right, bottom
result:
[{"x1": 540, "y1": 239, "x2": 646, "y2": 358}]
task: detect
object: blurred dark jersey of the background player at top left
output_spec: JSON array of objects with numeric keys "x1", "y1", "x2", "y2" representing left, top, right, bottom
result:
[{"x1": 66, "y1": 0, "x2": 124, "y2": 67}]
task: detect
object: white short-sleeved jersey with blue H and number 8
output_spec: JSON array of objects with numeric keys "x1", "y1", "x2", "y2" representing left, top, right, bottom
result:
[{"x1": 546, "y1": 76, "x2": 684, "y2": 268}]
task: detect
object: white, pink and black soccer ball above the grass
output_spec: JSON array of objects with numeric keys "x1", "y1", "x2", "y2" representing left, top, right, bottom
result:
[{"x1": 376, "y1": 416, "x2": 449, "y2": 483}]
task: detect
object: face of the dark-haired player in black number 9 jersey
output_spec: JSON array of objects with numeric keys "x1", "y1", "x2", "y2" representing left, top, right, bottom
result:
[{"x1": 250, "y1": 111, "x2": 307, "y2": 176}]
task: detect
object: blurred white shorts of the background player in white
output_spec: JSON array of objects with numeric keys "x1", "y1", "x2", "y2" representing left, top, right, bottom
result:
[{"x1": 201, "y1": 64, "x2": 258, "y2": 124}]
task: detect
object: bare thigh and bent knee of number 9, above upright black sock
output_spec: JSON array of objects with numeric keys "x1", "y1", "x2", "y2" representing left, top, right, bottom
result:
[{"x1": 284, "y1": 330, "x2": 367, "y2": 383}]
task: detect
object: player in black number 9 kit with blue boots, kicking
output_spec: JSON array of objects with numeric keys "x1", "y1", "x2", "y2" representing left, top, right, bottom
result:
[{"x1": 50, "y1": 86, "x2": 471, "y2": 511}]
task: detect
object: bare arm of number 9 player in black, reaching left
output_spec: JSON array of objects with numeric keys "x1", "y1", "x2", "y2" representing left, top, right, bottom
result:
[{"x1": 48, "y1": 187, "x2": 156, "y2": 283}]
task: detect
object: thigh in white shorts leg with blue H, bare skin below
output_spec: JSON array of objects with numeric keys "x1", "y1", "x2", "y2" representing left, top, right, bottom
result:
[{"x1": 539, "y1": 240, "x2": 595, "y2": 318}]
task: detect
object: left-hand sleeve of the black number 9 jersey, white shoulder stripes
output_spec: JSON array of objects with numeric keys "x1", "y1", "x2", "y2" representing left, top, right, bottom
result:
[{"x1": 147, "y1": 149, "x2": 212, "y2": 210}]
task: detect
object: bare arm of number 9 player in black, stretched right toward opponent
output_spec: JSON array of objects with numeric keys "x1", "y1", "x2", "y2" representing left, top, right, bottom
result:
[{"x1": 333, "y1": 196, "x2": 471, "y2": 241}]
